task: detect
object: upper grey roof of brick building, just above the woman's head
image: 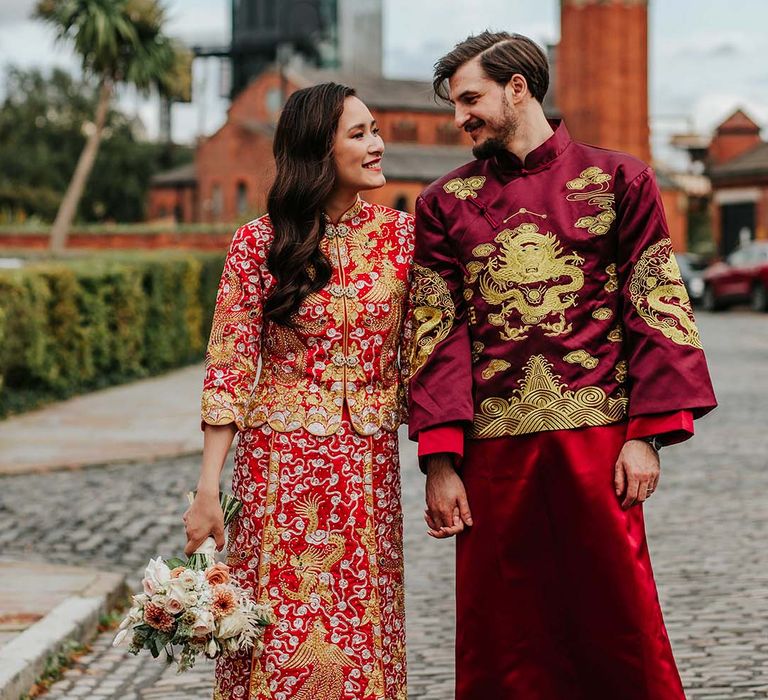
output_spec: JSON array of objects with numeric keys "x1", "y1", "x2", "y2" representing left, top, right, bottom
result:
[{"x1": 287, "y1": 66, "x2": 453, "y2": 114}]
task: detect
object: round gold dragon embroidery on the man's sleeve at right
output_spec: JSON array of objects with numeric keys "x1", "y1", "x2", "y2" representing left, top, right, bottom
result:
[{"x1": 629, "y1": 238, "x2": 702, "y2": 349}]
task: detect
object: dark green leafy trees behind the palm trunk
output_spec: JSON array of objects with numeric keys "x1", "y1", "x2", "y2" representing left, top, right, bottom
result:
[{"x1": 0, "y1": 68, "x2": 192, "y2": 223}]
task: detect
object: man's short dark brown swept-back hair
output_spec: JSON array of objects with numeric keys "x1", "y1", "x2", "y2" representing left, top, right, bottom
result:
[{"x1": 432, "y1": 30, "x2": 549, "y2": 102}]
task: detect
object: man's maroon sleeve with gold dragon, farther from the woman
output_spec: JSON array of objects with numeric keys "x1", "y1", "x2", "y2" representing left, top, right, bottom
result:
[{"x1": 617, "y1": 168, "x2": 716, "y2": 418}]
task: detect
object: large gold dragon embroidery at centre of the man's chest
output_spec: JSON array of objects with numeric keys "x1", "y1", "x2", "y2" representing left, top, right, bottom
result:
[{"x1": 472, "y1": 223, "x2": 584, "y2": 341}]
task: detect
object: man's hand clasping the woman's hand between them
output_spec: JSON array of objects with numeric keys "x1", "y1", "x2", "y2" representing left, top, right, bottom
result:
[{"x1": 424, "y1": 454, "x2": 472, "y2": 539}]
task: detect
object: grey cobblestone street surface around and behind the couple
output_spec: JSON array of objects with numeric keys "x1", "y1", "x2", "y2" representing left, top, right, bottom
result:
[{"x1": 0, "y1": 311, "x2": 768, "y2": 700}]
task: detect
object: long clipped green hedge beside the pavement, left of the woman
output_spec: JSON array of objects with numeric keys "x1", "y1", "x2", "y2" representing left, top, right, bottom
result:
[{"x1": 0, "y1": 252, "x2": 224, "y2": 416}]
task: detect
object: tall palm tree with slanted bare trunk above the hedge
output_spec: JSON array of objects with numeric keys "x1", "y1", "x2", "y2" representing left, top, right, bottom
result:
[{"x1": 35, "y1": 0, "x2": 192, "y2": 253}]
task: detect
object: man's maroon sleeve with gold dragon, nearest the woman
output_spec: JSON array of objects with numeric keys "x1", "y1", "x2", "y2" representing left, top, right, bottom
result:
[{"x1": 408, "y1": 197, "x2": 473, "y2": 442}]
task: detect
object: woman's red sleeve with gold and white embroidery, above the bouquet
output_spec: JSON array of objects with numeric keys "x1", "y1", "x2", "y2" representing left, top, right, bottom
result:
[{"x1": 202, "y1": 225, "x2": 263, "y2": 430}]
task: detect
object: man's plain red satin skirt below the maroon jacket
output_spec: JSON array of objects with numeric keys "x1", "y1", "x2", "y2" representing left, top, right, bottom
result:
[{"x1": 456, "y1": 424, "x2": 685, "y2": 700}]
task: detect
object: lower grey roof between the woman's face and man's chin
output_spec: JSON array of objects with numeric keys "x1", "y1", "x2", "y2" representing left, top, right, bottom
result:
[{"x1": 383, "y1": 143, "x2": 473, "y2": 183}]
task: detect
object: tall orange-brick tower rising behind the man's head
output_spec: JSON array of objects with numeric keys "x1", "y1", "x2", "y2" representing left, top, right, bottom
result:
[{"x1": 556, "y1": 0, "x2": 651, "y2": 162}]
